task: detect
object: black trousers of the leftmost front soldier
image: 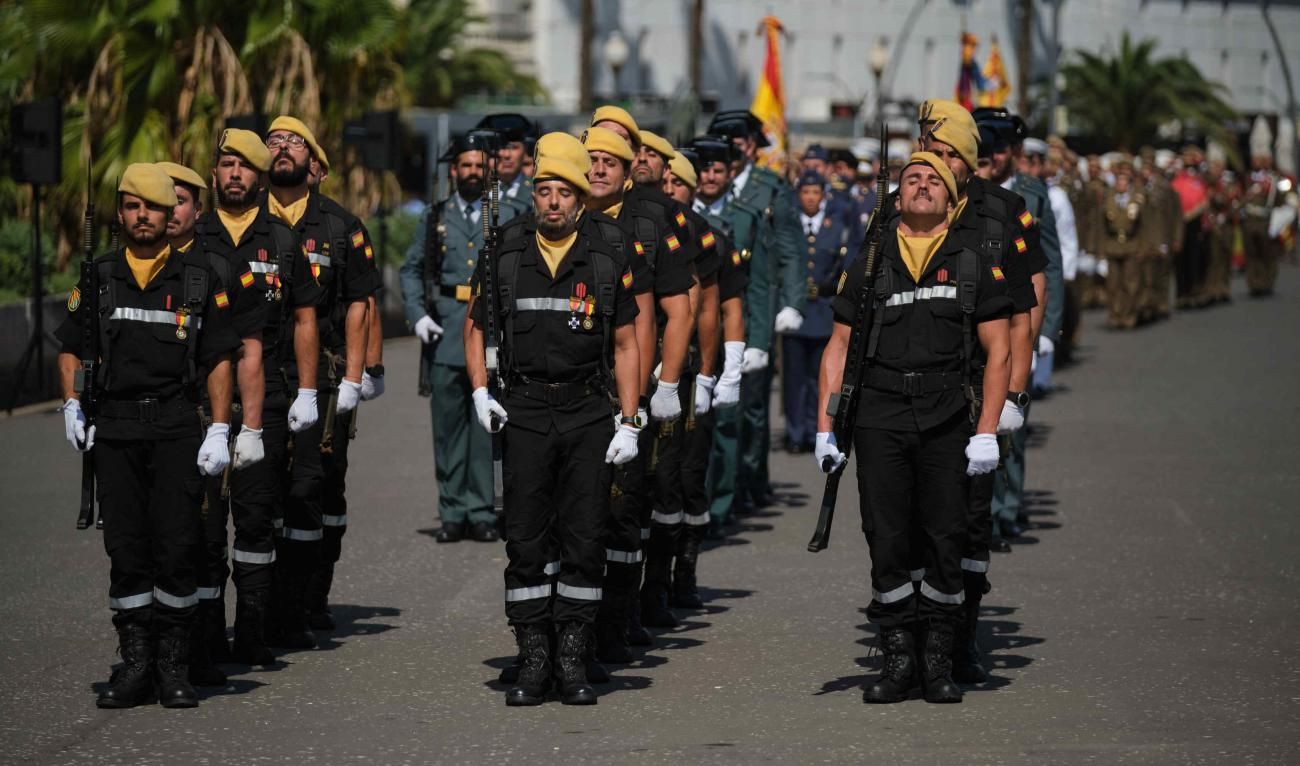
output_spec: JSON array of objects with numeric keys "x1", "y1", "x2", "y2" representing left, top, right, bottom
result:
[{"x1": 95, "y1": 428, "x2": 203, "y2": 629}]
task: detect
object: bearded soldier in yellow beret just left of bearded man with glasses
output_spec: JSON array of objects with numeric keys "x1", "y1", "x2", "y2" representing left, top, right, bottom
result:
[{"x1": 196, "y1": 130, "x2": 321, "y2": 665}]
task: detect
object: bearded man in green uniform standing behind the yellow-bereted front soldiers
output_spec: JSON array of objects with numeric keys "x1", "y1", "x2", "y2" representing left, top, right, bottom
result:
[{"x1": 400, "y1": 138, "x2": 525, "y2": 542}]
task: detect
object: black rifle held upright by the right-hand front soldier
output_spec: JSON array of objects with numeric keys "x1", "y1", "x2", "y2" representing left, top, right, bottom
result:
[{"x1": 809, "y1": 122, "x2": 889, "y2": 553}]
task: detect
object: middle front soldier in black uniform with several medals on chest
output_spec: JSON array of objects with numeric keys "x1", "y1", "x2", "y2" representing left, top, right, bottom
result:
[{"x1": 465, "y1": 157, "x2": 640, "y2": 705}]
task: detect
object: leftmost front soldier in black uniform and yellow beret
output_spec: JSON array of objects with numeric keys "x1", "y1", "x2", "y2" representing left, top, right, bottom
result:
[{"x1": 56, "y1": 164, "x2": 239, "y2": 707}]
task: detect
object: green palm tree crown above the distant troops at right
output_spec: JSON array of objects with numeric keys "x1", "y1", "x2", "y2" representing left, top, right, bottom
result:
[{"x1": 1061, "y1": 33, "x2": 1236, "y2": 152}]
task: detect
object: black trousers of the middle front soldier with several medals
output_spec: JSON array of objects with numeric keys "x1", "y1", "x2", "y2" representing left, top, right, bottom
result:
[{"x1": 502, "y1": 417, "x2": 614, "y2": 626}]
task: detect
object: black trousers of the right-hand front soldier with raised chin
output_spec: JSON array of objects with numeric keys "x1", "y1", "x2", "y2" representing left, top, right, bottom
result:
[{"x1": 854, "y1": 408, "x2": 972, "y2": 628}]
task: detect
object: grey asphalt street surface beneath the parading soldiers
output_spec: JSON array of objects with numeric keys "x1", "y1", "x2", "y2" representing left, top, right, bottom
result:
[{"x1": 0, "y1": 267, "x2": 1300, "y2": 765}]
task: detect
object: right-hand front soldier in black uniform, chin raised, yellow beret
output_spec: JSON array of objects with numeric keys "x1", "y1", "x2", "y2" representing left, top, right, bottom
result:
[{"x1": 816, "y1": 152, "x2": 1011, "y2": 702}]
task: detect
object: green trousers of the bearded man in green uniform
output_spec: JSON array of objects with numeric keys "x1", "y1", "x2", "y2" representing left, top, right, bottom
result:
[{"x1": 421, "y1": 360, "x2": 497, "y2": 524}]
